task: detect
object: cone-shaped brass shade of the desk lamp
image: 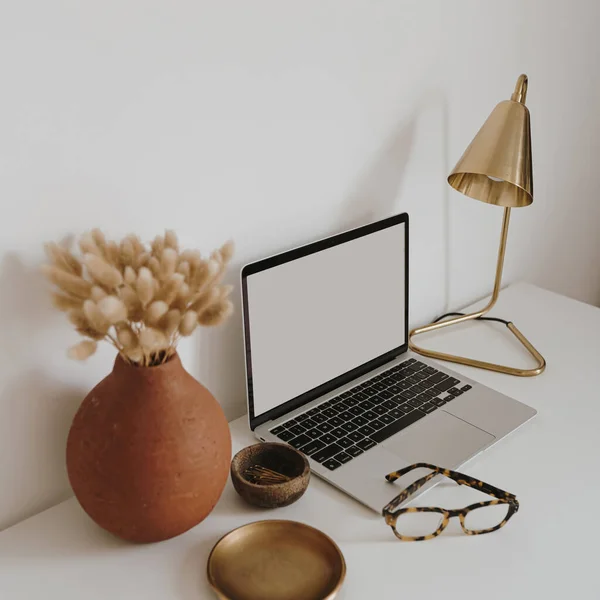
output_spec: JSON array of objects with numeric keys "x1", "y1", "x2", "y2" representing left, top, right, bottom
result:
[{"x1": 448, "y1": 75, "x2": 533, "y2": 208}]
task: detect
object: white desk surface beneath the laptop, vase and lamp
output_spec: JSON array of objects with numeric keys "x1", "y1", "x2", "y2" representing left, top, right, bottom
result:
[{"x1": 0, "y1": 284, "x2": 600, "y2": 600}]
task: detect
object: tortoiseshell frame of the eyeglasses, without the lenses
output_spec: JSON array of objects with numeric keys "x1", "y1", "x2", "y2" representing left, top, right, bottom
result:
[{"x1": 381, "y1": 463, "x2": 519, "y2": 542}]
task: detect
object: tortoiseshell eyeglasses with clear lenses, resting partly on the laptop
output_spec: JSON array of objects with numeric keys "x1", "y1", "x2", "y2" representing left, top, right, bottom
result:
[{"x1": 382, "y1": 463, "x2": 519, "y2": 542}]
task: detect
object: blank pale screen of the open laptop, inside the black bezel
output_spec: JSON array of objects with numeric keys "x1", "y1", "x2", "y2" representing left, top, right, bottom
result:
[{"x1": 246, "y1": 222, "x2": 407, "y2": 417}]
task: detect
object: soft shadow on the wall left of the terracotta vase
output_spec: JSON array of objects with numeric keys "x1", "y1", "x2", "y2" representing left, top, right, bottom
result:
[{"x1": 0, "y1": 254, "x2": 87, "y2": 530}]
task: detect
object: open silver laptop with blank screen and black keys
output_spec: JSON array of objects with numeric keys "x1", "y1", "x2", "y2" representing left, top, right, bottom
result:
[{"x1": 241, "y1": 213, "x2": 536, "y2": 512}]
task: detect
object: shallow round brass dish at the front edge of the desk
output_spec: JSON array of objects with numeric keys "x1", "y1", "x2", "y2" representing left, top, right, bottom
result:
[{"x1": 207, "y1": 520, "x2": 346, "y2": 600}]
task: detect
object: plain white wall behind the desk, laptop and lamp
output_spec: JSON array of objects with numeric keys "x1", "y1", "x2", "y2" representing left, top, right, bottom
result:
[{"x1": 0, "y1": 0, "x2": 600, "y2": 529}]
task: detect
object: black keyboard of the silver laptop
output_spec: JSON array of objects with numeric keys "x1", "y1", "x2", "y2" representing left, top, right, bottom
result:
[{"x1": 270, "y1": 358, "x2": 471, "y2": 471}]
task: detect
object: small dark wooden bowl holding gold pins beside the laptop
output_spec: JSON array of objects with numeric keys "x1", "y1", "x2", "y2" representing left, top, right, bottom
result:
[{"x1": 231, "y1": 442, "x2": 310, "y2": 508}]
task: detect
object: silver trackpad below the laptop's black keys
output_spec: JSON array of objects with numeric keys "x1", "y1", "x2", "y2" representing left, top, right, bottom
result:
[{"x1": 382, "y1": 410, "x2": 496, "y2": 469}]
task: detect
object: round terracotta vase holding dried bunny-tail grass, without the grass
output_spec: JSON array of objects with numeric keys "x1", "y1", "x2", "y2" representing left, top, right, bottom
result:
[{"x1": 67, "y1": 355, "x2": 231, "y2": 542}]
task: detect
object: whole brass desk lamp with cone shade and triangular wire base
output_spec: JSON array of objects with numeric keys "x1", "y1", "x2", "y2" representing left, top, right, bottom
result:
[{"x1": 408, "y1": 75, "x2": 546, "y2": 377}]
